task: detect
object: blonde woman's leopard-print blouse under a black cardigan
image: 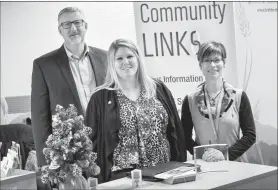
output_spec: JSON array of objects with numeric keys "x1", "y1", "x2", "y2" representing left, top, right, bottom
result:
[{"x1": 111, "y1": 90, "x2": 170, "y2": 172}]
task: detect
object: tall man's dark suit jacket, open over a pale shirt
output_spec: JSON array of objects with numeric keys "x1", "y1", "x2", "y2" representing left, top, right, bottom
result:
[{"x1": 31, "y1": 45, "x2": 107, "y2": 166}]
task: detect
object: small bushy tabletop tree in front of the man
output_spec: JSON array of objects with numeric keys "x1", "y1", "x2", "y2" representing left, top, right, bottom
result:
[{"x1": 41, "y1": 104, "x2": 100, "y2": 184}]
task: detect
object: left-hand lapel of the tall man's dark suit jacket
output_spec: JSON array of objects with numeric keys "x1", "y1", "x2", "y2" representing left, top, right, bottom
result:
[{"x1": 58, "y1": 46, "x2": 84, "y2": 115}]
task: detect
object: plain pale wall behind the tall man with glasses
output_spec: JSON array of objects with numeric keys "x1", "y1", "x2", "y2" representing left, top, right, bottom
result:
[{"x1": 1, "y1": 2, "x2": 136, "y2": 96}]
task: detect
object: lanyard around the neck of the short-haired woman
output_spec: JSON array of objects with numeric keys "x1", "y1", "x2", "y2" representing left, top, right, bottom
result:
[{"x1": 205, "y1": 86, "x2": 224, "y2": 143}]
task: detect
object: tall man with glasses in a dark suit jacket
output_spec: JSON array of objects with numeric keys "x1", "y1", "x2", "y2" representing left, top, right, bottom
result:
[{"x1": 31, "y1": 7, "x2": 107, "y2": 166}]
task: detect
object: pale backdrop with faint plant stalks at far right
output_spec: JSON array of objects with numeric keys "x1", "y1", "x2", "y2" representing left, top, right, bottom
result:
[{"x1": 234, "y1": 2, "x2": 277, "y2": 166}]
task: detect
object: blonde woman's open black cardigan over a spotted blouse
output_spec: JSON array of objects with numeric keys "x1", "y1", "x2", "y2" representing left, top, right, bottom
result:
[{"x1": 85, "y1": 81, "x2": 187, "y2": 183}]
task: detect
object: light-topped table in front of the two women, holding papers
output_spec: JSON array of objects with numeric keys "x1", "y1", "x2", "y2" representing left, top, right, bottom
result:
[{"x1": 98, "y1": 160, "x2": 277, "y2": 189}]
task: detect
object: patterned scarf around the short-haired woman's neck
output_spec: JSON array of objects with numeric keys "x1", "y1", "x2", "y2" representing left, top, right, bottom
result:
[{"x1": 194, "y1": 79, "x2": 236, "y2": 119}]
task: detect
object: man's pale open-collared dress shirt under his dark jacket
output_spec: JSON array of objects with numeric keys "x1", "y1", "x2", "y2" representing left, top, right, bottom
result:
[{"x1": 64, "y1": 45, "x2": 96, "y2": 114}]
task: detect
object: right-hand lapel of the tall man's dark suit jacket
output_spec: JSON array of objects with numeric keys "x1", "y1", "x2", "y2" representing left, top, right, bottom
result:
[{"x1": 89, "y1": 47, "x2": 105, "y2": 86}]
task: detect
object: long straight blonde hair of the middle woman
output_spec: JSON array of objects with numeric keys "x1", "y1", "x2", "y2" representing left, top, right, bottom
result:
[{"x1": 94, "y1": 39, "x2": 156, "y2": 98}]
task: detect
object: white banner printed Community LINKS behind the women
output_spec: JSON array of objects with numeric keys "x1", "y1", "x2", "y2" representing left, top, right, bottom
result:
[{"x1": 134, "y1": 2, "x2": 237, "y2": 111}]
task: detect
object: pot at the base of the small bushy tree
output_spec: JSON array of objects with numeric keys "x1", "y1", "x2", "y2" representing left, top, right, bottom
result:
[{"x1": 58, "y1": 175, "x2": 90, "y2": 190}]
